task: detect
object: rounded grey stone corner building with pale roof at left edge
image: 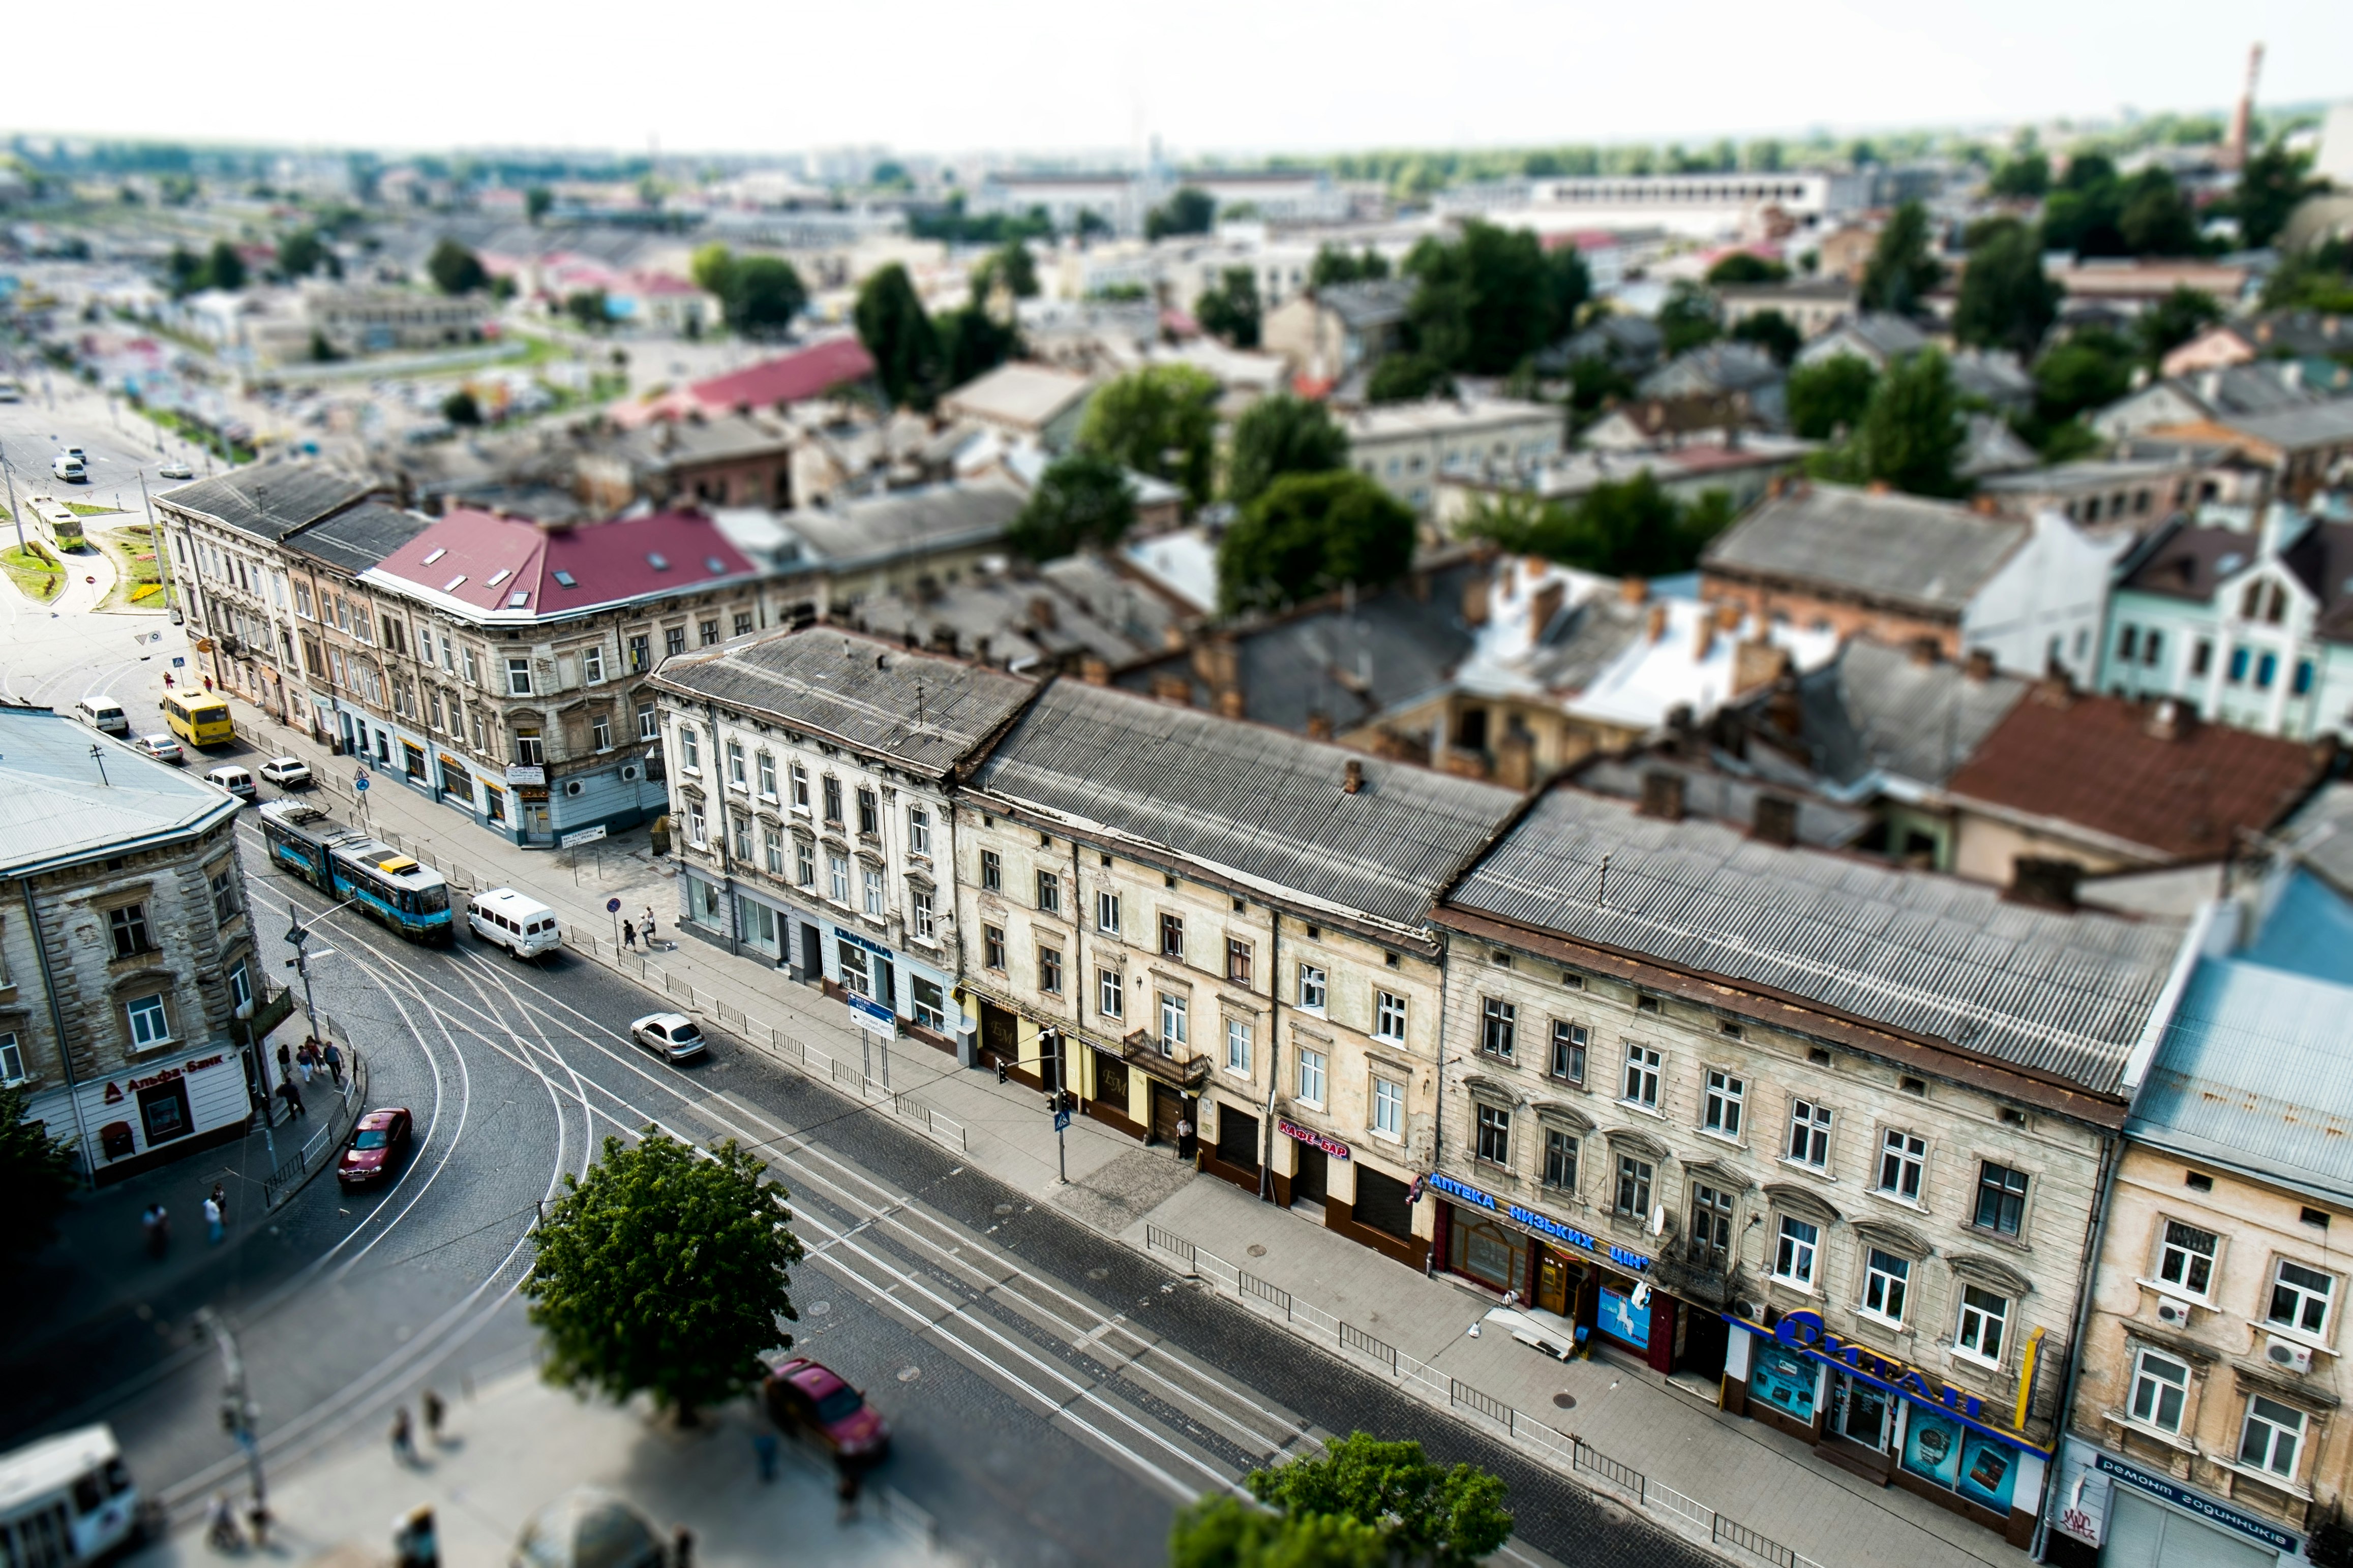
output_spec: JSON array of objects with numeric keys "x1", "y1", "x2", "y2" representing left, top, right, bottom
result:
[{"x1": 0, "y1": 705, "x2": 287, "y2": 1182}]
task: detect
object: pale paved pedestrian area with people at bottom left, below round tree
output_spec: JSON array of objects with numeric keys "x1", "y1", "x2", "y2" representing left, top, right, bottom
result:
[{"x1": 130, "y1": 1366, "x2": 951, "y2": 1568}]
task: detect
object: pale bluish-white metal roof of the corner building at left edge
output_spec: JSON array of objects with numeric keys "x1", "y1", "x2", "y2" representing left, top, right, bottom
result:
[{"x1": 0, "y1": 708, "x2": 237, "y2": 877}]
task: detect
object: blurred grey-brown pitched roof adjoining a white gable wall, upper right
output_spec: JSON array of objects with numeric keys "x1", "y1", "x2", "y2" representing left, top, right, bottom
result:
[{"x1": 1701, "y1": 484, "x2": 2031, "y2": 613}]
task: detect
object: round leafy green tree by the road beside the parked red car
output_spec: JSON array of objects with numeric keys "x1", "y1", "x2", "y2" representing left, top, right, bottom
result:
[{"x1": 522, "y1": 1126, "x2": 800, "y2": 1422}]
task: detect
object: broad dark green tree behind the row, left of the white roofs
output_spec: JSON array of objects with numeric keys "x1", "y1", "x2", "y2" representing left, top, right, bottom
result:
[{"x1": 1217, "y1": 468, "x2": 1414, "y2": 616}]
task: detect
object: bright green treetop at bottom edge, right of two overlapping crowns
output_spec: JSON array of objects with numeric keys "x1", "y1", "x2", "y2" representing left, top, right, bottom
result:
[{"x1": 1243, "y1": 1432, "x2": 1511, "y2": 1568}]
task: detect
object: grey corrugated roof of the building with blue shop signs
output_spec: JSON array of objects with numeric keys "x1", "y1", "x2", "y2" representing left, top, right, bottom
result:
[{"x1": 1447, "y1": 787, "x2": 2181, "y2": 1093}]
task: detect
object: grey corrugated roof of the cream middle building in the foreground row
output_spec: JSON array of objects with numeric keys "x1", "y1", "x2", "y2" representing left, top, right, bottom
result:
[{"x1": 972, "y1": 682, "x2": 1518, "y2": 924}]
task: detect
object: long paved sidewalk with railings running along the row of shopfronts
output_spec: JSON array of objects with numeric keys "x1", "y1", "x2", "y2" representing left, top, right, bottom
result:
[{"x1": 216, "y1": 719, "x2": 2031, "y2": 1568}]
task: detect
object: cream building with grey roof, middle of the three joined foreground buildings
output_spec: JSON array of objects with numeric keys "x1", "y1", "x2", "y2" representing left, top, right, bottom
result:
[{"x1": 955, "y1": 680, "x2": 1518, "y2": 1267}]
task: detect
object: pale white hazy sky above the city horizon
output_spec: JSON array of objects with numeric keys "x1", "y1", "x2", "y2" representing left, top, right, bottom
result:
[{"x1": 18, "y1": 0, "x2": 2353, "y2": 153}]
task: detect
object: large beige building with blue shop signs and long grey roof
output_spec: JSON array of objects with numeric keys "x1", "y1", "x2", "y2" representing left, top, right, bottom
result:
[{"x1": 1428, "y1": 787, "x2": 2184, "y2": 1545}]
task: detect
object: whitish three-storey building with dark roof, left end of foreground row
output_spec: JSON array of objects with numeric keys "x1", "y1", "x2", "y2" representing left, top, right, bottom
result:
[{"x1": 649, "y1": 628, "x2": 1035, "y2": 1060}]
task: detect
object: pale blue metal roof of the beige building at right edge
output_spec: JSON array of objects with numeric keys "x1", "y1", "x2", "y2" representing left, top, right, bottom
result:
[{"x1": 2125, "y1": 959, "x2": 2353, "y2": 1199}]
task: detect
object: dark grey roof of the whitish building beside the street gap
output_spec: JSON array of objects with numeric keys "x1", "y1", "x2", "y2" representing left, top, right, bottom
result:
[{"x1": 654, "y1": 625, "x2": 1038, "y2": 776}]
